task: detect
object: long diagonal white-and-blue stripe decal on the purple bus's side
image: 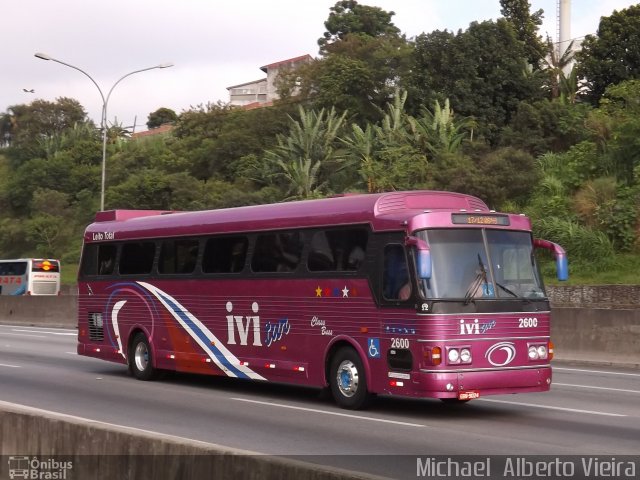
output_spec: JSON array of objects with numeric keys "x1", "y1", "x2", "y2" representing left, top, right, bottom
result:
[{"x1": 138, "y1": 282, "x2": 266, "y2": 380}]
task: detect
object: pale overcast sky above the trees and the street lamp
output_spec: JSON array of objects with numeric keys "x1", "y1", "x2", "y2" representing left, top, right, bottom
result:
[{"x1": 0, "y1": 0, "x2": 636, "y2": 131}]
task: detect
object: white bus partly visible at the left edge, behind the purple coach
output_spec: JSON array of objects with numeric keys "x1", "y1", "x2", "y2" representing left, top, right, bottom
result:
[{"x1": 0, "y1": 258, "x2": 60, "y2": 295}]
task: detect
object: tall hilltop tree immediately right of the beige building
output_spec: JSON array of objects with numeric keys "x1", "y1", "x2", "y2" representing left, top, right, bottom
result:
[{"x1": 278, "y1": 0, "x2": 411, "y2": 125}]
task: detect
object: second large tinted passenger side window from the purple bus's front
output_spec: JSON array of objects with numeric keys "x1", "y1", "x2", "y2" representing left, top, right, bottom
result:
[{"x1": 251, "y1": 232, "x2": 302, "y2": 272}]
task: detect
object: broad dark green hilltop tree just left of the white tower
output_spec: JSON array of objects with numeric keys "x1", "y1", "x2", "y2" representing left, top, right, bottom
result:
[{"x1": 409, "y1": 19, "x2": 544, "y2": 145}]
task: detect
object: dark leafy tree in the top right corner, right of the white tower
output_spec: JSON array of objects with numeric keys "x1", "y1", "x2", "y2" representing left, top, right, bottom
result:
[{"x1": 576, "y1": 5, "x2": 640, "y2": 105}]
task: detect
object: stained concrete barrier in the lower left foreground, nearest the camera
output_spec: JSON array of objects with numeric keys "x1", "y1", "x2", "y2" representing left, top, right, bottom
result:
[{"x1": 0, "y1": 401, "x2": 383, "y2": 480}]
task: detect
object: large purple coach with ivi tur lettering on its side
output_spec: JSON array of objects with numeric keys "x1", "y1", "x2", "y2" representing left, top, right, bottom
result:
[{"x1": 78, "y1": 191, "x2": 567, "y2": 409}]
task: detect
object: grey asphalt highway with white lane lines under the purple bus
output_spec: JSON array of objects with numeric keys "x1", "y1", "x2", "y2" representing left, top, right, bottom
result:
[{"x1": 0, "y1": 325, "x2": 640, "y2": 478}]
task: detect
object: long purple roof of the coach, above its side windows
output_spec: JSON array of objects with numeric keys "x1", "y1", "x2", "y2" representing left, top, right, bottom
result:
[{"x1": 85, "y1": 190, "x2": 489, "y2": 242}]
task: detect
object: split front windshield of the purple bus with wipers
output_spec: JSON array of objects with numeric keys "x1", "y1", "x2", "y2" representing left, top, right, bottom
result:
[{"x1": 418, "y1": 229, "x2": 545, "y2": 300}]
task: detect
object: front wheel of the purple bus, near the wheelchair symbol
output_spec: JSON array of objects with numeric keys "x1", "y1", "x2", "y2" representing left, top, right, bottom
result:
[{"x1": 329, "y1": 347, "x2": 370, "y2": 410}]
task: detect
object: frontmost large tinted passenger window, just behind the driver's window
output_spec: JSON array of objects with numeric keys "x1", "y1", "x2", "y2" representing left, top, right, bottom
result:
[{"x1": 307, "y1": 228, "x2": 367, "y2": 272}]
